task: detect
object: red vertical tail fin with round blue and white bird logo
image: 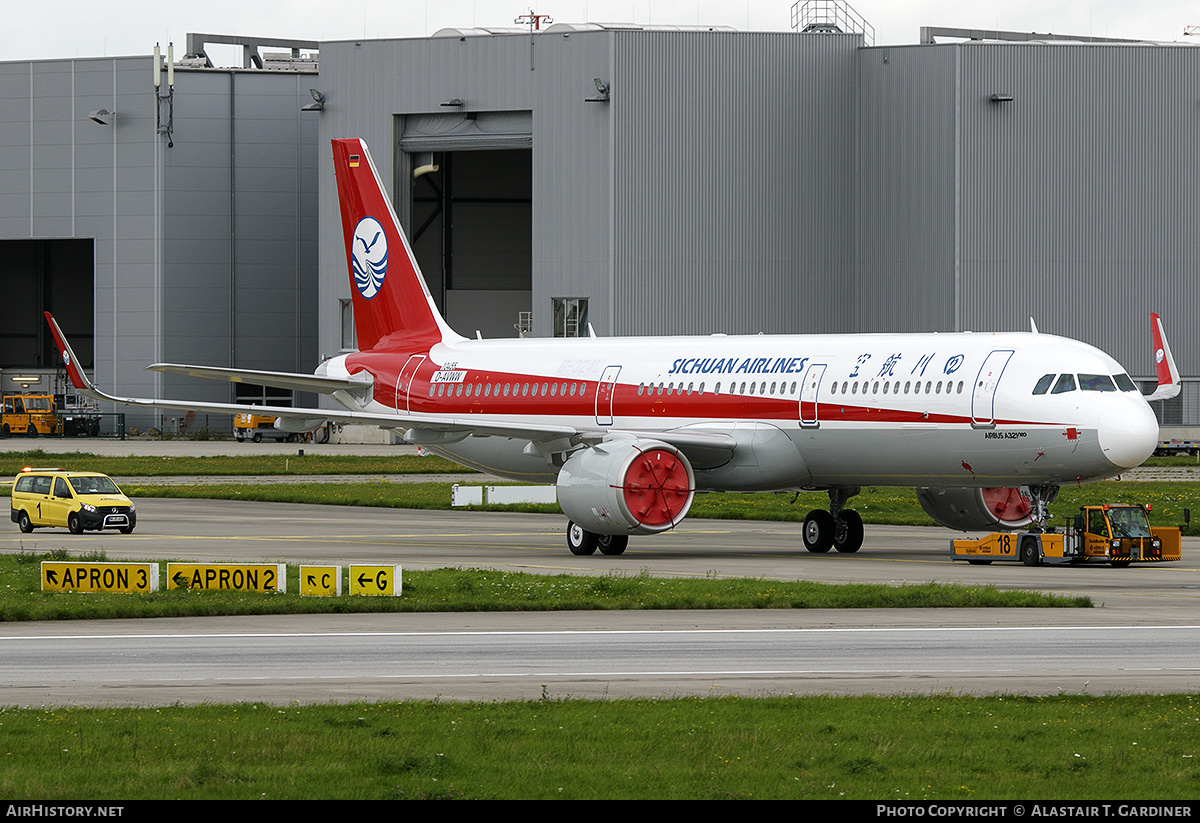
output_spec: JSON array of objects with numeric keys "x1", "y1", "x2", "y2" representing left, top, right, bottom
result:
[{"x1": 334, "y1": 139, "x2": 458, "y2": 352}]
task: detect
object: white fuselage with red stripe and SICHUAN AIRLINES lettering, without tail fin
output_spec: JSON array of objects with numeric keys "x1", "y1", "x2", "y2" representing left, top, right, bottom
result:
[{"x1": 326, "y1": 332, "x2": 1158, "y2": 491}]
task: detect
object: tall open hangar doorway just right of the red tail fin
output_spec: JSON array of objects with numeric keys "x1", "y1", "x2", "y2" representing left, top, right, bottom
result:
[{"x1": 396, "y1": 112, "x2": 533, "y2": 337}]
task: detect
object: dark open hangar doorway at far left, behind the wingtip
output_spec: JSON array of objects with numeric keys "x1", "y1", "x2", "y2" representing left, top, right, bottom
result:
[{"x1": 0, "y1": 239, "x2": 96, "y2": 371}]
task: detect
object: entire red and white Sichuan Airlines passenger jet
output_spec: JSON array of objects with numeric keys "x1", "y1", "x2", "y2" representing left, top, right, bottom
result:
[{"x1": 47, "y1": 139, "x2": 1181, "y2": 554}]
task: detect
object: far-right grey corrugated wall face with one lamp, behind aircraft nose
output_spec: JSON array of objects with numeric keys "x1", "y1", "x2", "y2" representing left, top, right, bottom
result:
[{"x1": 956, "y1": 44, "x2": 1200, "y2": 377}]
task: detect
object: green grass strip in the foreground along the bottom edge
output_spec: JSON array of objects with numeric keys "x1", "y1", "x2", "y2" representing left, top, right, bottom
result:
[{"x1": 0, "y1": 684, "x2": 1200, "y2": 801}]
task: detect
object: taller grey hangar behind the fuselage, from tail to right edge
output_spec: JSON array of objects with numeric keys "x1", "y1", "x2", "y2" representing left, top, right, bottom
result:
[{"x1": 319, "y1": 25, "x2": 1200, "y2": 425}]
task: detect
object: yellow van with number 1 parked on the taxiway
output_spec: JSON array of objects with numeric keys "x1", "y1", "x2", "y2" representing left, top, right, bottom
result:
[{"x1": 12, "y1": 469, "x2": 137, "y2": 534}]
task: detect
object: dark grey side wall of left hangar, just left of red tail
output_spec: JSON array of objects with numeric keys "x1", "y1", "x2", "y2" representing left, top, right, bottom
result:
[{"x1": 162, "y1": 71, "x2": 318, "y2": 400}]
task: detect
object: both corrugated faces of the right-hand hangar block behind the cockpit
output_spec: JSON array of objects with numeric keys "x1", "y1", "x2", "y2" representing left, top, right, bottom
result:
[{"x1": 856, "y1": 43, "x2": 1200, "y2": 393}]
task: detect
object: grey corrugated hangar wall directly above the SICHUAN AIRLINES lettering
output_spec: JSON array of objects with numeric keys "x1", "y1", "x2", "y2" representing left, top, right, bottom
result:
[{"x1": 612, "y1": 31, "x2": 862, "y2": 334}]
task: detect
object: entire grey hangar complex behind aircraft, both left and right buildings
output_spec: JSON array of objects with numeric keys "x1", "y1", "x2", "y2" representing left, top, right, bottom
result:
[{"x1": 0, "y1": 14, "x2": 1200, "y2": 425}]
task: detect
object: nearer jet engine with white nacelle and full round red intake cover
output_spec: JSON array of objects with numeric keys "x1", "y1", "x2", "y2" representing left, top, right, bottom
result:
[{"x1": 557, "y1": 439, "x2": 696, "y2": 534}]
